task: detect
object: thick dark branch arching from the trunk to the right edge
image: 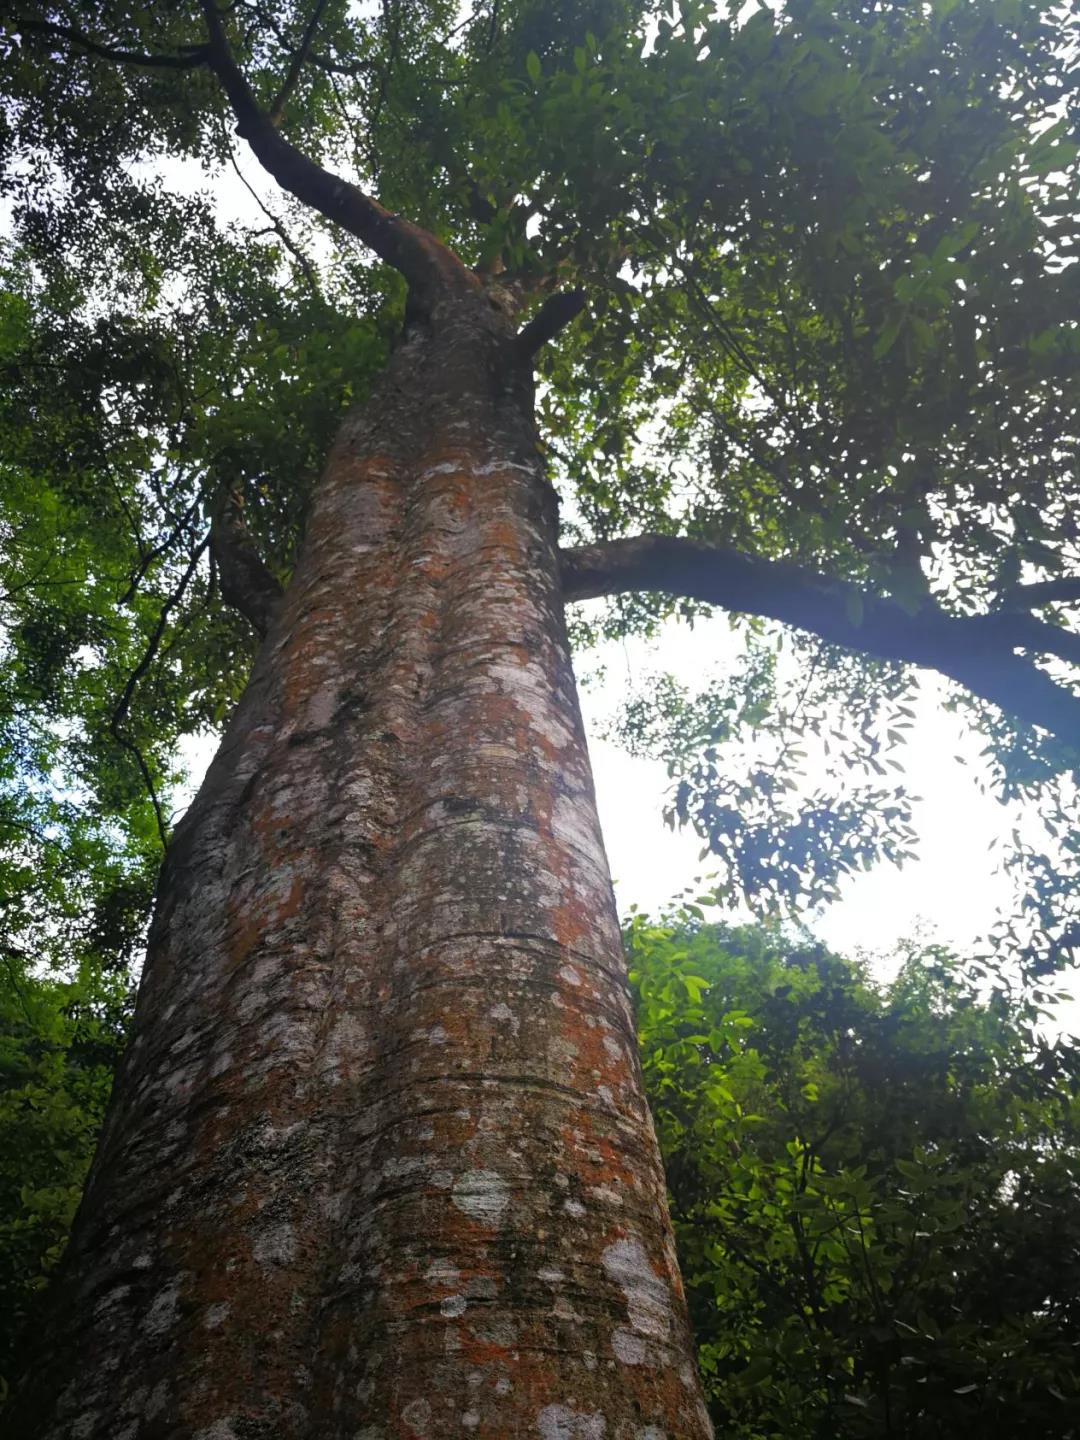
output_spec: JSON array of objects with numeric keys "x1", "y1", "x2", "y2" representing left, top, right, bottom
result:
[{"x1": 562, "y1": 536, "x2": 1080, "y2": 746}]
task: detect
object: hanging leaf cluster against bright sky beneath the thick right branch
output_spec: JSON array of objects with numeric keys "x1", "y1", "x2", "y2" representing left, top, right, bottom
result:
[{"x1": 618, "y1": 632, "x2": 916, "y2": 912}]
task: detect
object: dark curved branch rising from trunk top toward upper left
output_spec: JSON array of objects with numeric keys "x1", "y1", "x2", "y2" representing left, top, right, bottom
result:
[{"x1": 202, "y1": 0, "x2": 480, "y2": 295}]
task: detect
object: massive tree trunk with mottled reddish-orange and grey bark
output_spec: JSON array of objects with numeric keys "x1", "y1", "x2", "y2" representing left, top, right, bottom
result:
[{"x1": 9, "y1": 294, "x2": 720, "y2": 1440}]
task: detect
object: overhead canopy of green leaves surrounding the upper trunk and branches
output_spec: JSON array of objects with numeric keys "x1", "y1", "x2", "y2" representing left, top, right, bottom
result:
[{"x1": 0, "y1": 0, "x2": 1080, "y2": 990}]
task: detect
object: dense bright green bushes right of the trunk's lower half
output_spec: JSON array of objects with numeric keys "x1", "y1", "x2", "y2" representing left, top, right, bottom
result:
[{"x1": 628, "y1": 906, "x2": 1080, "y2": 1440}]
